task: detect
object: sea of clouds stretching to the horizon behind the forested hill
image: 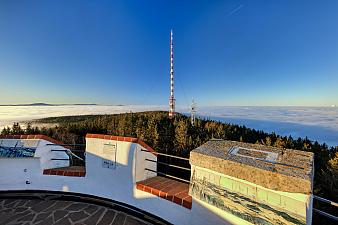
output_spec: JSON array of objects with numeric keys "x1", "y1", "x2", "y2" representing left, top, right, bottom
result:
[{"x1": 0, "y1": 105, "x2": 338, "y2": 146}]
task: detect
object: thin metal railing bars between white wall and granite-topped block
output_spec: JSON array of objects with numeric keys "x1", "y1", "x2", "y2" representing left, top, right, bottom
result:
[{"x1": 141, "y1": 149, "x2": 191, "y2": 183}]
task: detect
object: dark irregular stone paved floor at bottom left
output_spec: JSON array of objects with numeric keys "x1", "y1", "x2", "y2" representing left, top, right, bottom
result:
[{"x1": 0, "y1": 199, "x2": 149, "y2": 225}]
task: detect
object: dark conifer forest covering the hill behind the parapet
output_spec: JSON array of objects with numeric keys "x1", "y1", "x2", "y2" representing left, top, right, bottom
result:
[{"x1": 2, "y1": 111, "x2": 338, "y2": 220}]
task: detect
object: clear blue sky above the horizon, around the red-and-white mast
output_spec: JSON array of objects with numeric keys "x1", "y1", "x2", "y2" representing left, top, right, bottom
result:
[{"x1": 0, "y1": 0, "x2": 338, "y2": 106}]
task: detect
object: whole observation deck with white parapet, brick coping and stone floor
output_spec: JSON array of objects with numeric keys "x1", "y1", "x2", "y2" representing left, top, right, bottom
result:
[{"x1": 0, "y1": 134, "x2": 330, "y2": 225}]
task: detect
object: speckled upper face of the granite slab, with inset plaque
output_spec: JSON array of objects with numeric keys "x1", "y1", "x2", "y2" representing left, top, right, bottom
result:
[{"x1": 190, "y1": 139, "x2": 314, "y2": 183}]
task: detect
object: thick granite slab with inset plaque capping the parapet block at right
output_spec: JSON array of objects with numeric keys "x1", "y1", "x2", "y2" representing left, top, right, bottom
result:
[{"x1": 190, "y1": 140, "x2": 314, "y2": 194}]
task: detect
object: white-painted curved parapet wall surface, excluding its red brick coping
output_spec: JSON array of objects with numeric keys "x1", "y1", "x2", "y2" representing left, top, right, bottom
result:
[{"x1": 0, "y1": 138, "x2": 230, "y2": 225}]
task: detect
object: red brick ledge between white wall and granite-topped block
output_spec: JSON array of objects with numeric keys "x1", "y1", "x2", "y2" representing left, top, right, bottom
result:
[{"x1": 136, "y1": 176, "x2": 192, "y2": 209}]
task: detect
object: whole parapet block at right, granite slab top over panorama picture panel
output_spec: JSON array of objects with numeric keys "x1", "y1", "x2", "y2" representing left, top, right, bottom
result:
[{"x1": 189, "y1": 140, "x2": 314, "y2": 224}]
